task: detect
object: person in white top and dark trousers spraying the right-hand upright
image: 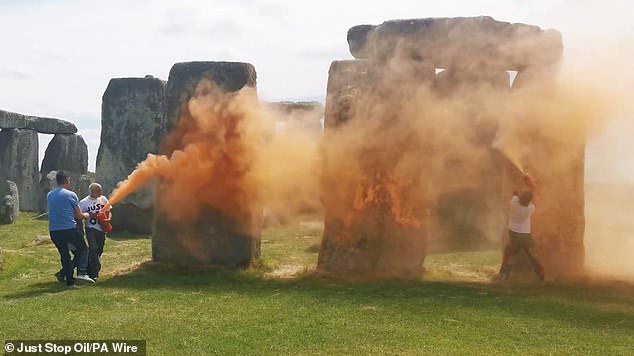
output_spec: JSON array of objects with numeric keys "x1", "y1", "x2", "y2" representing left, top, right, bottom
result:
[{"x1": 499, "y1": 174, "x2": 545, "y2": 281}]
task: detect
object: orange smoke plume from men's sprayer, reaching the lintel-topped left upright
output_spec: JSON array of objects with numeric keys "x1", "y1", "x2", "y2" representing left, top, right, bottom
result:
[{"x1": 111, "y1": 79, "x2": 319, "y2": 222}]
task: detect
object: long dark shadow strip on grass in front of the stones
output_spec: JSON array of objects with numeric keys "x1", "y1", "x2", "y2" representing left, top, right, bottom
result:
[{"x1": 89, "y1": 262, "x2": 634, "y2": 332}]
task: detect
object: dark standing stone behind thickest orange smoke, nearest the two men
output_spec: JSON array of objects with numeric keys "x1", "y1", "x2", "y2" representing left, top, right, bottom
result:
[{"x1": 152, "y1": 62, "x2": 261, "y2": 267}]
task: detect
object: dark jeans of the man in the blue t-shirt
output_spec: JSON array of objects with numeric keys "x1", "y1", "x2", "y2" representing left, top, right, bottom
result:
[{"x1": 50, "y1": 229, "x2": 88, "y2": 284}]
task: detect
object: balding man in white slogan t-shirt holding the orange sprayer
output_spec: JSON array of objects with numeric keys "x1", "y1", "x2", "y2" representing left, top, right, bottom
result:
[{"x1": 79, "y1": 183, "x2": 112, "y2": 281}]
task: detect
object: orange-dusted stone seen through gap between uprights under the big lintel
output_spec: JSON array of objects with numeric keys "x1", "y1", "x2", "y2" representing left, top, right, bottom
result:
[{"x1": 431, "y1": 67, "x2": 510, "y2": 249}]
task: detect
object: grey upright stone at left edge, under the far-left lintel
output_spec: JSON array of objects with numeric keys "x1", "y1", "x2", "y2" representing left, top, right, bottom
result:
[{"x1": 0, "y1": 129, "x2": 40, "y2": 211}]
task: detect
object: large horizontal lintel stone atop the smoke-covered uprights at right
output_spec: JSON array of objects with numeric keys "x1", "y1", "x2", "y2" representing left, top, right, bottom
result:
[{"x1": 348, "y1": 16, "x2": 563, "y2": 70}]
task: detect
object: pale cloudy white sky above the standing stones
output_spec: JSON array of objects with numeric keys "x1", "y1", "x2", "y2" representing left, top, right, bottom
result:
[{"x1": 0, "y1": 0, "x2": 634, "y2": 178}]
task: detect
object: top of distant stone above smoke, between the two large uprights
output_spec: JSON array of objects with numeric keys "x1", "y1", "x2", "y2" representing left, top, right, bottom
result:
[{"x1": 268, "y1": 101, "x2": 324, "y2": 133}]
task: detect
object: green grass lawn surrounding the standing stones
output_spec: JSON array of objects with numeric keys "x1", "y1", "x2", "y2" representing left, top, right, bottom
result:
[{"x1": 0, "y1": 214, "x2": 634, "y2": 355}]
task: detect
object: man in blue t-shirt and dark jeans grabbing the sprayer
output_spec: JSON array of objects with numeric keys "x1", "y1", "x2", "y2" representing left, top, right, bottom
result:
[{"x1": 46, "y1": 171, "x2": 95, "y2": 286}]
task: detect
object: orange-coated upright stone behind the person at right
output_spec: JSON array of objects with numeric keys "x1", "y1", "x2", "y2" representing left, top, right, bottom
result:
[{"x1": 504, "y1": 78, "x2": 586, "y2": 280}]
